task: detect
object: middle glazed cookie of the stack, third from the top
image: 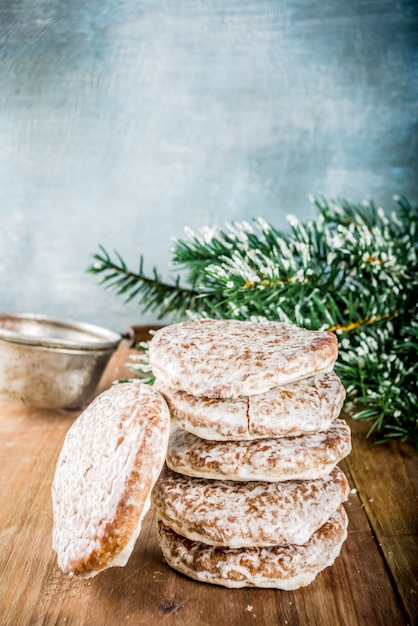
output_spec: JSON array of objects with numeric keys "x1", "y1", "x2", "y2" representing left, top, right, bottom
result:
[{"x1": 167, "y1": 419, "x2": 351, "y2": 481}]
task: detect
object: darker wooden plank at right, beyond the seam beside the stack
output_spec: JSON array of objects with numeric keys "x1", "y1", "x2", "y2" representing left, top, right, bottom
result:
[{"x1": 347, "y1": 419, "x2": 418, "y2": 624}]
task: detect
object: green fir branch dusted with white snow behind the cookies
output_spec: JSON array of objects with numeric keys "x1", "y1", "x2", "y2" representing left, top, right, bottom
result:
[{"x1": 89, "y1": 198, "x2": 418, "y2": 448}]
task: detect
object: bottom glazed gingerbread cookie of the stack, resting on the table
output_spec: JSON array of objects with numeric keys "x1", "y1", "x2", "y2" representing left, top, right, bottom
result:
[{"x1": 158, "y1": 506, "x2": 348, "y2": 591}]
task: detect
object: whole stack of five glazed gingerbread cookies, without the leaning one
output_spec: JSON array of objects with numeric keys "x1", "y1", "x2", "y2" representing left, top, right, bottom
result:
[{"x1": 149, "y1": 320, "x2": 351, "y2": 590}]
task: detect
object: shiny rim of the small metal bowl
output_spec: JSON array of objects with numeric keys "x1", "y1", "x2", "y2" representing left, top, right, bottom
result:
[{"x1": 0, "y1": 312, "x2": 122, "y2": 352}]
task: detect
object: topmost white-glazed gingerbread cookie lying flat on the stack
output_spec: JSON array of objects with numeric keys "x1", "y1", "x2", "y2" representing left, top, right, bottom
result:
[{"x1": 149, "y1": 320, "x2": 337, "y2": 398}]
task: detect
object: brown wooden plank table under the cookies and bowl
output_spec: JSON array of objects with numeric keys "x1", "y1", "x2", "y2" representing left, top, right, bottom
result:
[{"x1": 0, "y1": 330, "x2": 418, "y2": 626}]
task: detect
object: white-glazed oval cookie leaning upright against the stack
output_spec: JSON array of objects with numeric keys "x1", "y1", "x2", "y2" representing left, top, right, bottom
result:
[{"x1": 52, "y1": 383, "x2": 170, "y2": 578}]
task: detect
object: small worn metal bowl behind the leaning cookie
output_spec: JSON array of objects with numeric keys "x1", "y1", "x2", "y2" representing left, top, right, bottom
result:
[{"x1": 0, "y1": 313, "x2": 122, "y2": 409}]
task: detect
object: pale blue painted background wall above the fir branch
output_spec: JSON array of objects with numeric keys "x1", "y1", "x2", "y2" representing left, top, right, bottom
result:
[{"x1": 0, "y1": 0, "x2": 418, "y2": 330}]
